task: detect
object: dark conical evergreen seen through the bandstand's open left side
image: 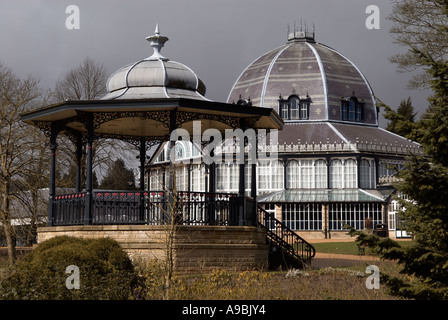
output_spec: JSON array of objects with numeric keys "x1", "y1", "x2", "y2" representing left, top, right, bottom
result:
[{"x1": 100, "y1": 158, "x2": 135, "y2": 190}]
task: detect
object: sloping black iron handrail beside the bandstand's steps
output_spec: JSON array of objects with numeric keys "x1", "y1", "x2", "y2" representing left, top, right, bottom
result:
[{"x1": 257, "y1": 206, "x2": 316, "y2": 264}]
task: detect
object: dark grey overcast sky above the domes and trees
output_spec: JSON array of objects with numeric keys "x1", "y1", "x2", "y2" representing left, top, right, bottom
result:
[{"x1": 0, "y1": 0, "x2": 434, "y2": 126}]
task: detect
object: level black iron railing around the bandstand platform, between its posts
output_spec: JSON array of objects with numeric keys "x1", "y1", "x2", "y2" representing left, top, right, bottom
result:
[{"x1": 52, "y1": 190, "x2": 245, "y2": 226}]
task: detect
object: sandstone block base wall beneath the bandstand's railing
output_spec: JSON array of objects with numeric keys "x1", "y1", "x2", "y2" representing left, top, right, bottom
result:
[{"x1": 37, "y1": 225, "x2": 269, "y2": 273}]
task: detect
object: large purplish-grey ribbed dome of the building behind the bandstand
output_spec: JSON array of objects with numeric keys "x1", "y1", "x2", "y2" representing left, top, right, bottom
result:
[{"x1": 228, "y1": 32, "x2": 378, "y2": 125}]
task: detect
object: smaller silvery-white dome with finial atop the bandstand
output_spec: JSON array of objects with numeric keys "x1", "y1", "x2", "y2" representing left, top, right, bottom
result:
[{"x1": 102, "y1": 26, "x2": 208, "y2": 100}]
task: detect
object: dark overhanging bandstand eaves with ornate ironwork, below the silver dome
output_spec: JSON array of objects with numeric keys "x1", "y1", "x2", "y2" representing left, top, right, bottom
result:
[{"x1": 21, "y1": 98, "x2": 283, "y2": 141}]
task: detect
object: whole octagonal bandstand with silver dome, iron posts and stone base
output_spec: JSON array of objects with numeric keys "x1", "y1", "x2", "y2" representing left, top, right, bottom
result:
[{"x1": 21, "y1": 27, "x2": 314, "y2": 271}]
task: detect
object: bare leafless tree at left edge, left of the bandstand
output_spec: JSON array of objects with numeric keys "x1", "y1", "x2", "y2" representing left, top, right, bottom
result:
[{"x1": 0, "y1": 64, "x2": 46, "y2": 264}]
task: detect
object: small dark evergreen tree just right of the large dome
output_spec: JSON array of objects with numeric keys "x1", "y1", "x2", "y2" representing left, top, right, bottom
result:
[{"x1": 384, "y1": 98, "x2": 416, "y2": 138}]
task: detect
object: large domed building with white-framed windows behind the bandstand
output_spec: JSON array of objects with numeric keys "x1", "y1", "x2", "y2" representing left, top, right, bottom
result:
[{"x1": 146, "y1": 31, "x2": 420, "y2": 239}]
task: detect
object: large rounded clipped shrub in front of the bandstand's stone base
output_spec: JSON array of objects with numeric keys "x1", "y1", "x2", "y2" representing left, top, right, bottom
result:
[{"x1": 0, "y1": 236, "x2": 137, "y2": 300}]
